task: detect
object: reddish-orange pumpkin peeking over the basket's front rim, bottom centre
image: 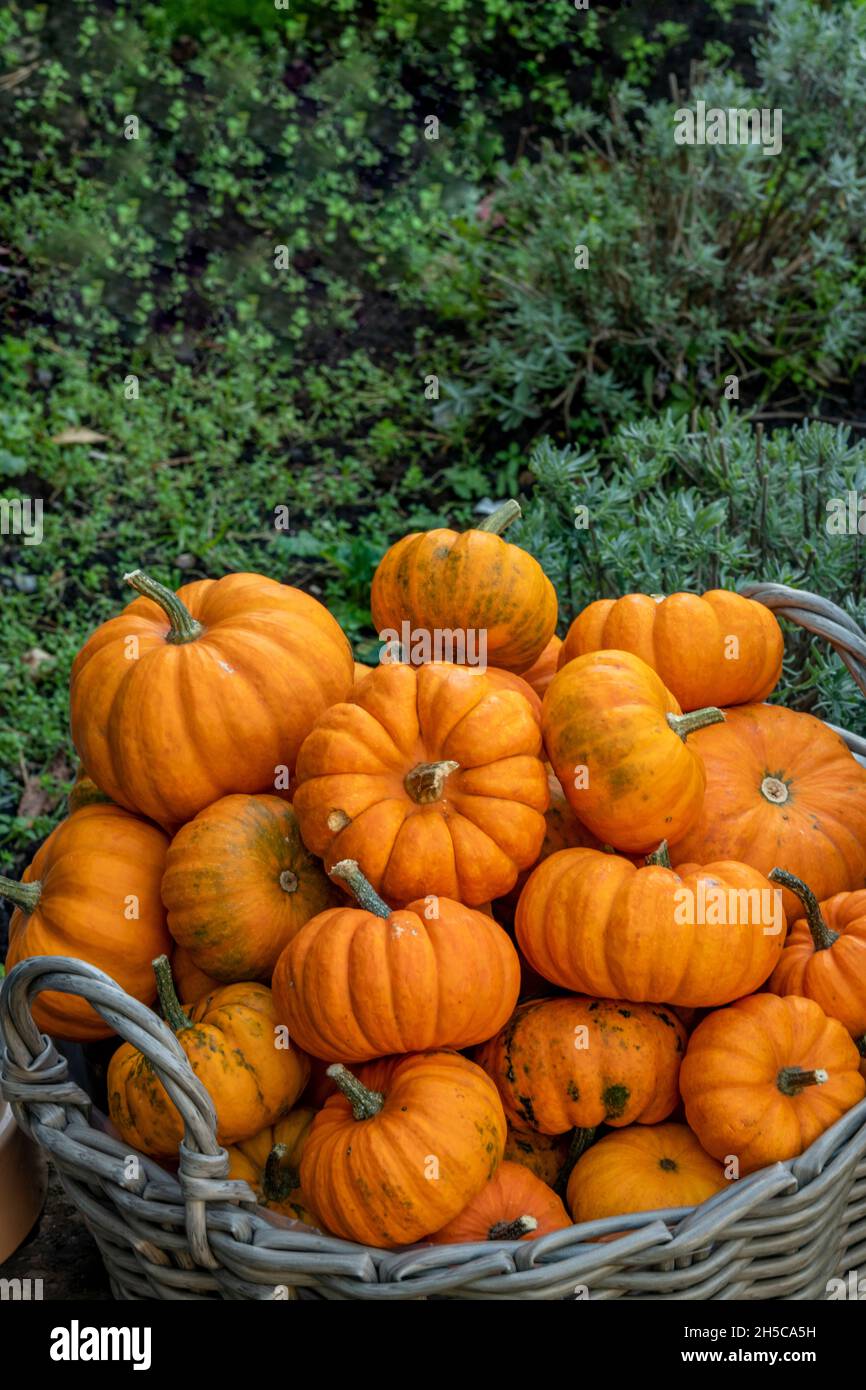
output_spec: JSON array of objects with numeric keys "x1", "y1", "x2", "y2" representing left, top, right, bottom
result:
[{"x1": 427, "y1": 1159, "x2": 571, "y2": 1245}]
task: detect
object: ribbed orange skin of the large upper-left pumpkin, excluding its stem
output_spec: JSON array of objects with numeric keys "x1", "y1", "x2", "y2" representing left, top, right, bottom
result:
[{"x1": 70, "y1": 574, "x2": 353, "y2": 830}]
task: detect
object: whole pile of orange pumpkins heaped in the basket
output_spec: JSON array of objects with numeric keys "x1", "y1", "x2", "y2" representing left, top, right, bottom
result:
[{"x1": 0, "y1": 505, "x2": 866, "y2": 1247}]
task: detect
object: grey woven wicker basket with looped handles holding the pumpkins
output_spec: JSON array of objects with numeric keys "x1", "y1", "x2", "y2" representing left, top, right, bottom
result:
[{"x1": 0, "y1": 584, "x2": 866, "y2": 1300}]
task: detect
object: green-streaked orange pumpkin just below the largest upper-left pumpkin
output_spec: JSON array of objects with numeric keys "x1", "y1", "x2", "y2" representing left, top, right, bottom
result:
[{"x1": 163, "y1": 795, "x2": 342, "y2": 983}]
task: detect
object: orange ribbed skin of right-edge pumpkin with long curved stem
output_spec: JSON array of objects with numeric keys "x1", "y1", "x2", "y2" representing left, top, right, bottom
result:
[{"x1": 767, "y1": 888, "x2": 866, "y2": 1038}]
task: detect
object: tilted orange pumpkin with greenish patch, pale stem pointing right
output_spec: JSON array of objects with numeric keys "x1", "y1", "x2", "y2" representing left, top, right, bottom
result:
[{"x1": 542, "y1": 651, "x2": 735, "y2": 859}]
